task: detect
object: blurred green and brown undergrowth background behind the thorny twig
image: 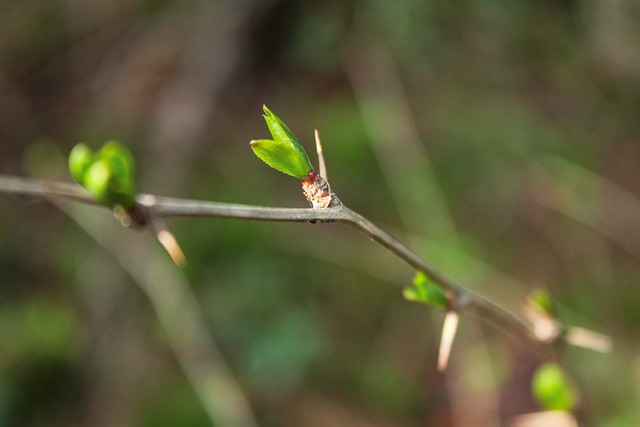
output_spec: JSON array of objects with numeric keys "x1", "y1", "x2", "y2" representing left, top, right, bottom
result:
[{"x1": 0, "y1": 0, "x2": 640, "y2": 427}]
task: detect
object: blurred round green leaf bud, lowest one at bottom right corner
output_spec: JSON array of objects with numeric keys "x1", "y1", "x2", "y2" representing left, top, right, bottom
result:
[{"x1": 531, "y1": 363, "x2": 578, "y2": 411}]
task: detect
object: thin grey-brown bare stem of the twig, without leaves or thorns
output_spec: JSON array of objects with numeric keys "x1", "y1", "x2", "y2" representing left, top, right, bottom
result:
[{"x1": 0, "y1": 175, "x2": 540, "y2": 344}]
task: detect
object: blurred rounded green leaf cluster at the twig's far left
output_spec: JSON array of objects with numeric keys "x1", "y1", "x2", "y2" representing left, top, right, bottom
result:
[{"x1": 69, "y1": 141, "x2": 135, "y2": 209}]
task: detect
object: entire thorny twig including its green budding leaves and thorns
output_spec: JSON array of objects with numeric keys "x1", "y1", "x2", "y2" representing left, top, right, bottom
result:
[{"x1": 0, "y1": 106, "x2": 608, "y2": 424}]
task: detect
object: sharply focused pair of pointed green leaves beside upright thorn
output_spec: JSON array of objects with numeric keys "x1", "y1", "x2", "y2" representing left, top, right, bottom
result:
[{"x1": 250, "y1": 105, "x2": 313, "y2": 179}]
